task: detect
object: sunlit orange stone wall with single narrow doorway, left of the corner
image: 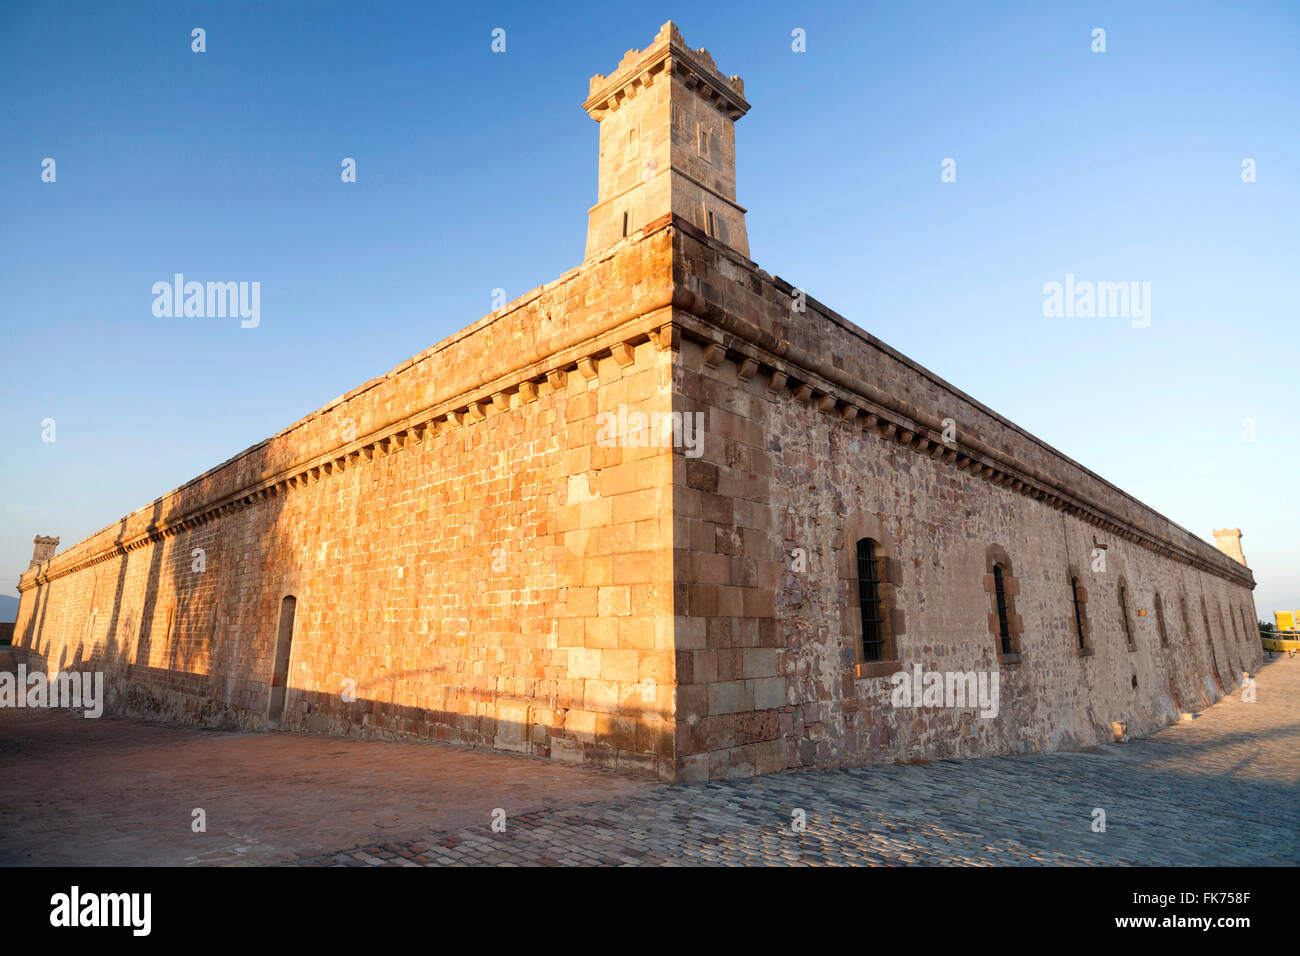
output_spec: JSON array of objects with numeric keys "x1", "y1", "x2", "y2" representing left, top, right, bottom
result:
[{"x1": 17, "y1": 226, "x2": 675, "y2": 775}]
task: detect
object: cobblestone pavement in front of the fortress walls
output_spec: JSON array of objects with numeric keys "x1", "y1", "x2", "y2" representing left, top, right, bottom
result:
[{"x1": 0, "y1": 657, "x2": 1300, "y2": 866}]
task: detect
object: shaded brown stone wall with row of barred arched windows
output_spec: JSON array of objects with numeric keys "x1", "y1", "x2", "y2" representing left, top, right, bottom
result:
[{"x1": 673, "y1": 226, "x2": 1261, "y2": 779}]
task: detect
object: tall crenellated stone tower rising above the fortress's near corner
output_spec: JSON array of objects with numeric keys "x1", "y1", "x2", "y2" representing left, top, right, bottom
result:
[{"x1": 582, "y1": 21, "x2": 749, "y2": 260}]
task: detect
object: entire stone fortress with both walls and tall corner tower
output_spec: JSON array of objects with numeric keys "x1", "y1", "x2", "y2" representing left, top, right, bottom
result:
[{"x1": 16, "y1": 23, "x2": 1262, "y2": 782}]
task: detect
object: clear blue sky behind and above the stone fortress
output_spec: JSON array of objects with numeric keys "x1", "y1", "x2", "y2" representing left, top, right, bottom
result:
[{"x1": 0, "y1": 0, "x2": 1300, "y2": 617}]
